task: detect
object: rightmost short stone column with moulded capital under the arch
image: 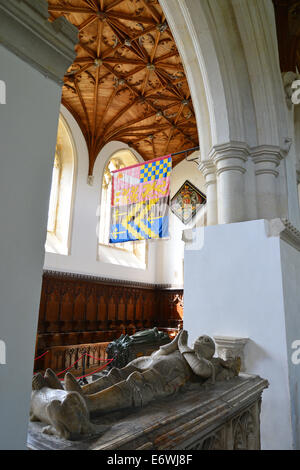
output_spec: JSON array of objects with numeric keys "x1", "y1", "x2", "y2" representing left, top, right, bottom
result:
[{"x1": 251, "y1": 145, "x2": 283, "y2": 219}]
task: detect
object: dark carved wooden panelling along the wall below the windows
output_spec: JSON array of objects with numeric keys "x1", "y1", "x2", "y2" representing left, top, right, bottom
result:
[{"x1": 35, "y1": 271, "x2": 183, "y2": 368}]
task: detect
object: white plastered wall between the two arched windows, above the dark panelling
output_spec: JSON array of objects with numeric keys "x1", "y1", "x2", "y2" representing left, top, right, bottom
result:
[{"x1": 44, "y1": 106, "x2": 156, "y2": 283}]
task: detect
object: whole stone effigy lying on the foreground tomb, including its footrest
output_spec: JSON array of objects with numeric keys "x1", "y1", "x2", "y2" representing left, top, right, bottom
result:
[{"x1": 30, "y1": 330, "x2": 240, "y2": 439}]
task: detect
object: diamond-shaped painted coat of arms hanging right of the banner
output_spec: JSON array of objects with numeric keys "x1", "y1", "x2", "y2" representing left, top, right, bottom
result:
[{"x1": 171, "y1": 180, "x2": 206, "y2": 224}]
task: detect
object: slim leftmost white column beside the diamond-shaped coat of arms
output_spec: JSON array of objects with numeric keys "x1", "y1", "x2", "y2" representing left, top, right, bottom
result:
[{"x1": 199, "y1": 160, "x2": 218, "y2": 225}]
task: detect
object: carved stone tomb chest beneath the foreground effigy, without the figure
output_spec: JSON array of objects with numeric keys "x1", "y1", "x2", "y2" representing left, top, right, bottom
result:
[{"x1": 28, "y1": 374, "x2": 268, "y2": 450}]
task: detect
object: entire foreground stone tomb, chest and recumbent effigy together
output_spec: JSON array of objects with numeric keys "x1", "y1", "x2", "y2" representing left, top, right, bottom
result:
[{"x1": 29, "y1": 331, "x2": 267, "y2": 449}]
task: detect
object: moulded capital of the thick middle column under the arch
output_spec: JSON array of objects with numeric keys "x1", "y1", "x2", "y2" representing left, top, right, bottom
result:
[{"x1": 209, "y1": 142, "x2": 249, "y2": 176}]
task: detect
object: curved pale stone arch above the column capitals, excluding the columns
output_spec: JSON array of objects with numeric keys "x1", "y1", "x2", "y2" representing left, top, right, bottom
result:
[{"x1": 160, "y1": 0, "x2": 287, "y2": 152}]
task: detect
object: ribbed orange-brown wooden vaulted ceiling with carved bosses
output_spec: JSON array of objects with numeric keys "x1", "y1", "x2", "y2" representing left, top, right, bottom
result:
[{"x1": 48, "y1": 0, "x2": 198, "y2": 175}]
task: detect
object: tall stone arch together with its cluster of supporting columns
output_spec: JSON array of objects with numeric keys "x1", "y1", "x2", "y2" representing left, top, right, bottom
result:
[{"x1": 160, "y1": 0, "x2": 288, "y2": 225}]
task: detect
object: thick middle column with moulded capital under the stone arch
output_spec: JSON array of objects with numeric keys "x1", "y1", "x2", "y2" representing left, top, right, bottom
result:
[{"x1": 210, "y1": 142, "x2": 249, "y2": 224}]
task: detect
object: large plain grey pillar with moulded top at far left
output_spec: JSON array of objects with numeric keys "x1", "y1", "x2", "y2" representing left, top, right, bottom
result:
[{"x1": 0, "y1": 0, "x2": 78, "y2": 450}]
